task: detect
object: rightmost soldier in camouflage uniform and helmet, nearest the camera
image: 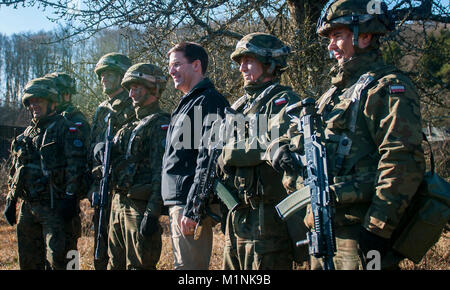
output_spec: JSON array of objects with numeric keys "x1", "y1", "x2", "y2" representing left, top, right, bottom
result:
[{"x1": 268, "y1": 0, "x2": 425, "y2": 269}]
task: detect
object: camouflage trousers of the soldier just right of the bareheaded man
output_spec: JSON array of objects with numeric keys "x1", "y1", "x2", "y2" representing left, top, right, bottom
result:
[{"x1": 223, "y1": 203, "x2": 293, "y2": 270}]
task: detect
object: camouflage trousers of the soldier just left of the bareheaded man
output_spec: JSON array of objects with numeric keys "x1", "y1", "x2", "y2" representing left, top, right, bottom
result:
[{"x1": 108, "y1": 194, "x2": 162, "y2": 270}]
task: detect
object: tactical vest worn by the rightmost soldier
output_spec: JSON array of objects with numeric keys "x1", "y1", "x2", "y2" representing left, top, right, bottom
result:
[{"x1": 318, "y1": 66, "x2": 397, "y2": 204}]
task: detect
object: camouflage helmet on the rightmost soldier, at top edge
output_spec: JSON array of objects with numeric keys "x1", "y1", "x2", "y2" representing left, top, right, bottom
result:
[{"x1": 316, "y1": 0, "x2": 395, "y2": 39}]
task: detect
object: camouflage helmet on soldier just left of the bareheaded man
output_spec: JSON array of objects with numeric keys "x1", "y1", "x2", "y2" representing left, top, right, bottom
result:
[{"x1": 122, "y1": 63, "x2": 167, "y2": 94}]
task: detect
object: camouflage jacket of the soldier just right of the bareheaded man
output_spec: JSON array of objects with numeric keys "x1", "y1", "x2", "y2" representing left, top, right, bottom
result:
[{"x1": 221, "y1": 81, "x2": 299, "y2": 203}]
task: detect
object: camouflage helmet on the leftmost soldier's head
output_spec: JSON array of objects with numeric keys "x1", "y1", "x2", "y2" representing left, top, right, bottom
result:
[{"x1": 22, "y1": 78, "x2": 60, "y2": 107}]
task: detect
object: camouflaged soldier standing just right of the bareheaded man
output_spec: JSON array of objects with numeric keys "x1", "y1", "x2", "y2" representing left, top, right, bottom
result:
[{"x1": 218, "y1": 33, "x2": 299, "y2": 270}]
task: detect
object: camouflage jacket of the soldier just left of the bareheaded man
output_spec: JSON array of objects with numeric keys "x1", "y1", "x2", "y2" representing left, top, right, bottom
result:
[{"x1": 111, "y1": 102, "x2": 170, "y2": 217}]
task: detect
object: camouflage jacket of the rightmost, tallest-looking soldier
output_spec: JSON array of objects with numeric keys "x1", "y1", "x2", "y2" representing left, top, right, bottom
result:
[{"x1": 268, "y1": 51, "x2": 425, "y2": 238}]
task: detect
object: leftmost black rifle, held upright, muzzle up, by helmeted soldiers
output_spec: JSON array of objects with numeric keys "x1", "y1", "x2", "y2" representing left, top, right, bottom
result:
[{"x1": 94, "y1": 113, "x2": 113, "y2": 260}]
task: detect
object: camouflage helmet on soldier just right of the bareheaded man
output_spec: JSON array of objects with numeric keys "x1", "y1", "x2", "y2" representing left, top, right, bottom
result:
[{"x1": 231, "y1": 32, "x2": 291, "y2": 71}]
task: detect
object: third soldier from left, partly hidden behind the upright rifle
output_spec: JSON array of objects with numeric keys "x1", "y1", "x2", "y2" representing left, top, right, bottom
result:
[{"x1": 88, "y1": 52, "x2": 136, "y2": 270}]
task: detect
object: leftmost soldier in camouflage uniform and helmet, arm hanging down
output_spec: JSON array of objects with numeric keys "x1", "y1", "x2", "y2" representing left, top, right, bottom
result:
[{"x1": 5, "y1": 78, "x2": 86, "y2": 269}]
